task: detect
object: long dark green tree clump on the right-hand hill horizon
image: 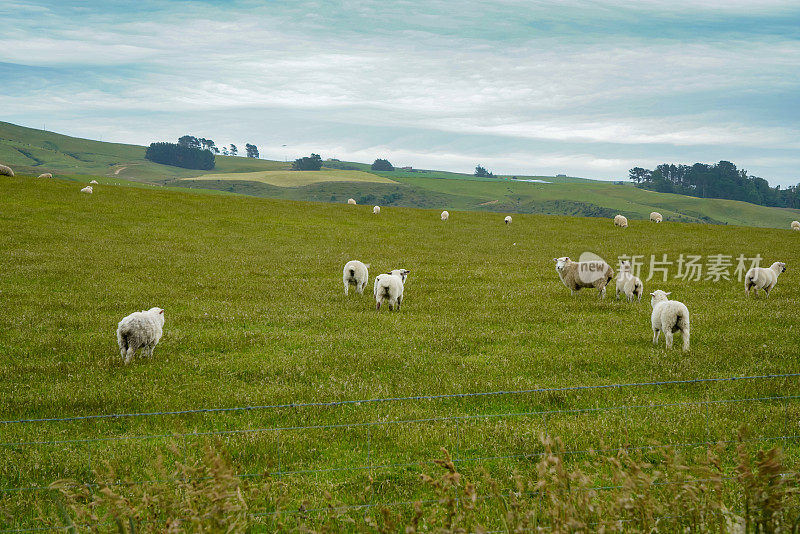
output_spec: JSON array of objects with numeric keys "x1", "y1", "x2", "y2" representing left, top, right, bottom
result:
[{"x1": 628, "y1": 161, "x2": 800, "y2": 208}]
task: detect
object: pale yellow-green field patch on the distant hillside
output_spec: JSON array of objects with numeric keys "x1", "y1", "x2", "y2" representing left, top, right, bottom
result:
[{"x1": 184, "y1": 169, "x2": 395, "y2": 191}]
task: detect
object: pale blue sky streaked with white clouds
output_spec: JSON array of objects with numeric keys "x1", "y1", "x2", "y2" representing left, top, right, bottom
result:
[{"x1": 0, "y1": 0, "x2": 800, "y2": 185}]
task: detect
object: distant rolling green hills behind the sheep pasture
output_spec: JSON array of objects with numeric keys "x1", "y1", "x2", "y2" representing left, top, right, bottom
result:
[{"x1": 0, "y1": 122, "x2": 800, "y2": 228}]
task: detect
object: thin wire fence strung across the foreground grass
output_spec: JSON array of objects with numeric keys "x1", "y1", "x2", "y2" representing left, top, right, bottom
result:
[{"x1": 0, "y1": 373, "x2": 800, "y2": 532}]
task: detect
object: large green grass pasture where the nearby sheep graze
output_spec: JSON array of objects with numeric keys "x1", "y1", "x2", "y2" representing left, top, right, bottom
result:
[{"x1": 0, "y1": 176, "x2": 800, "y2": 528}]
